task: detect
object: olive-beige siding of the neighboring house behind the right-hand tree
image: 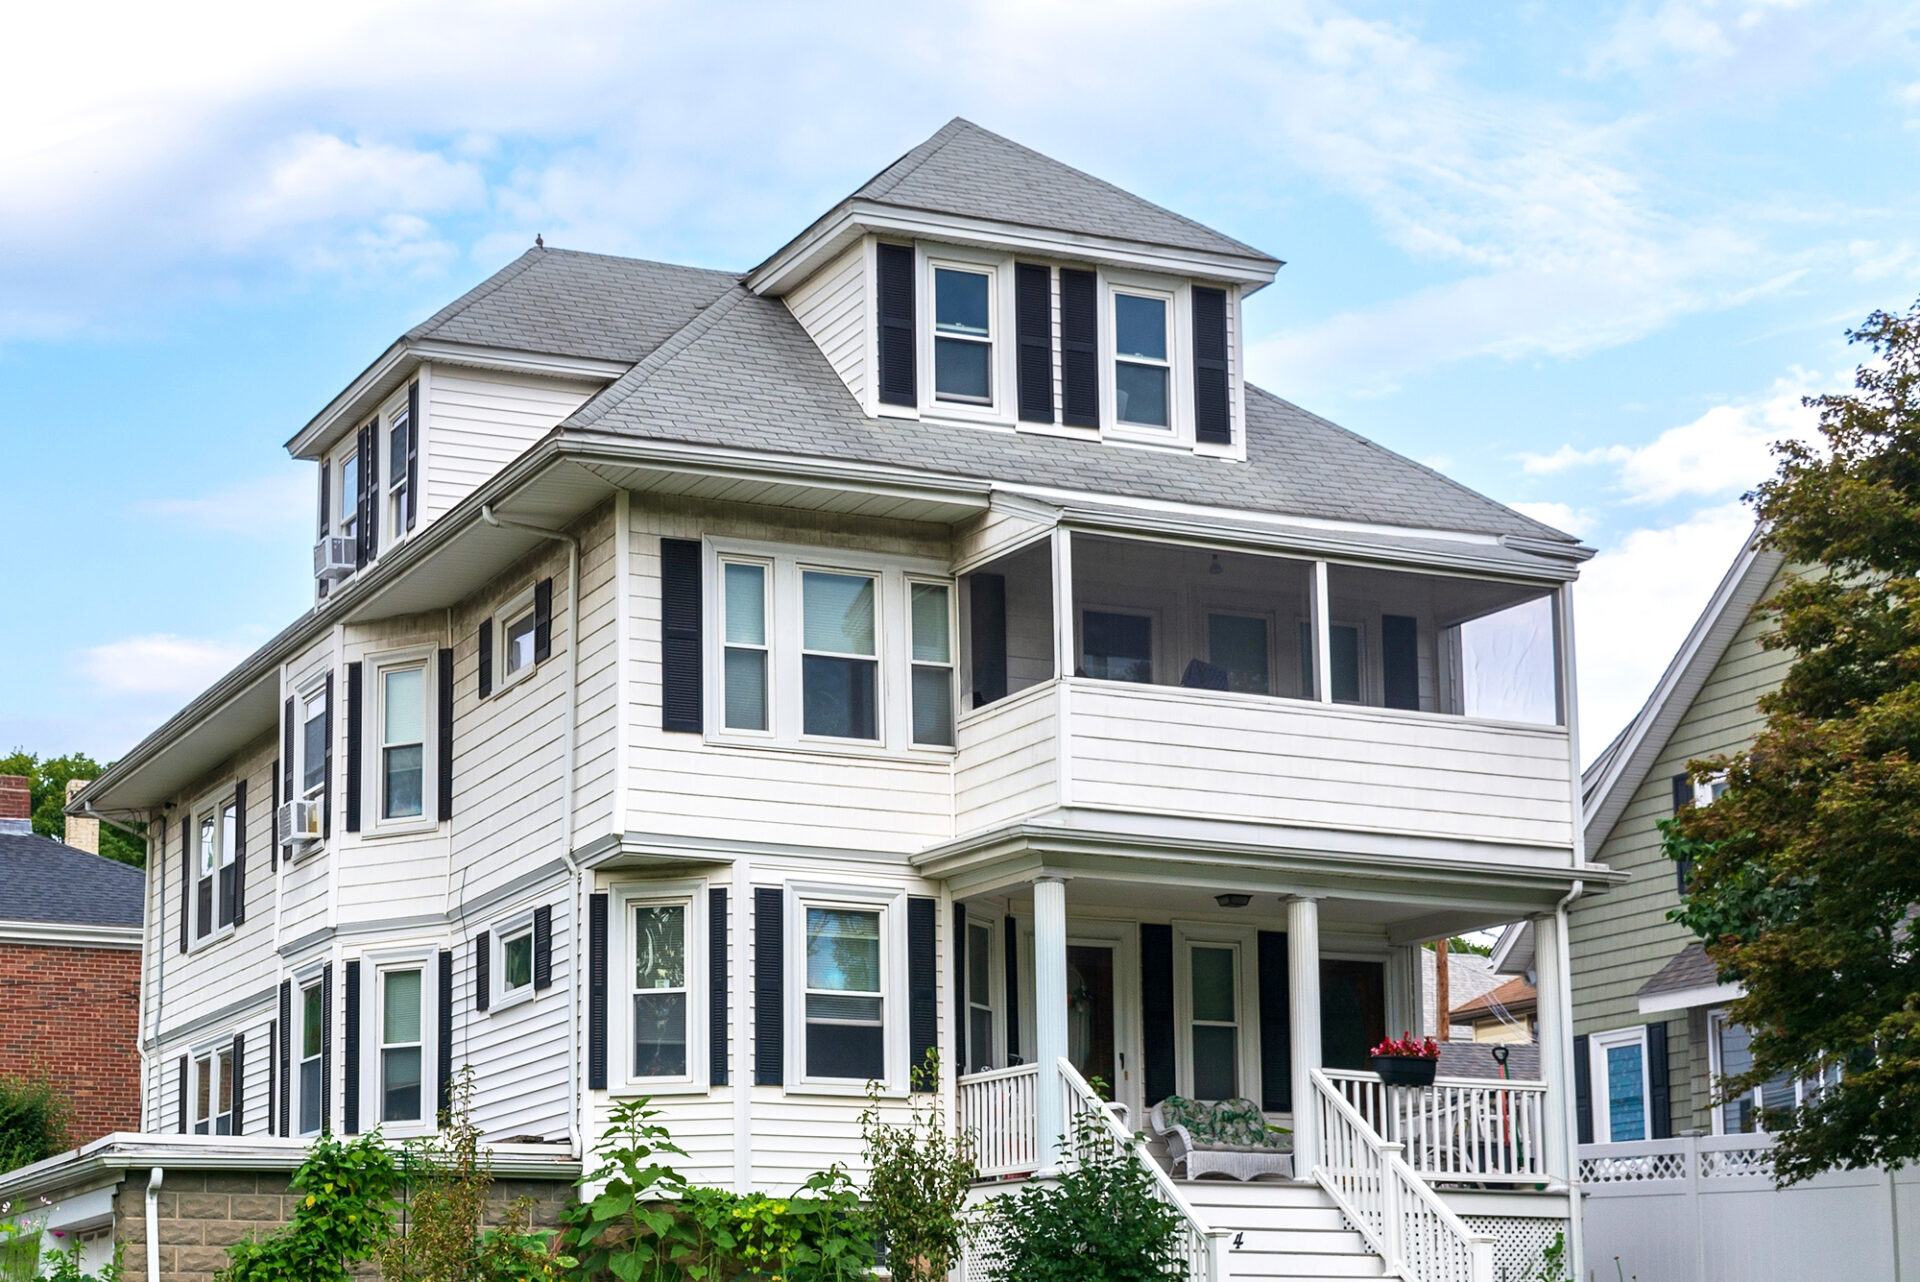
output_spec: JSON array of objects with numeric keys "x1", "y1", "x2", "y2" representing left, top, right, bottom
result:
[{"x1": 1569, "y1": 564, "x2": 1793, "y2": 1130}]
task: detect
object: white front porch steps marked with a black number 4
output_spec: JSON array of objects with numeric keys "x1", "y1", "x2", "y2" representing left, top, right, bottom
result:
[{"x1": 1181, "y1": 1180, "x2": 1386, "y2": 1282}]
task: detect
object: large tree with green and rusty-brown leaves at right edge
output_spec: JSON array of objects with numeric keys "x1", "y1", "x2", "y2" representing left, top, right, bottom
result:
[{"x1": 1665, "y1": 303, "x2": 1920, "y2": 1184}]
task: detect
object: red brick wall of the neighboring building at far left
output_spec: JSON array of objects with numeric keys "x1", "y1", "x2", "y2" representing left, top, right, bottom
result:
[{"x1": 0, "y1": 944, "x2": 140, "y2": 1144}]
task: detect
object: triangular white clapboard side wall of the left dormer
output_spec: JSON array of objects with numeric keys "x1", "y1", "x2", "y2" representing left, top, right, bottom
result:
[{"x1": 420, "y1": 365, "x2": 597, "y2": 520}]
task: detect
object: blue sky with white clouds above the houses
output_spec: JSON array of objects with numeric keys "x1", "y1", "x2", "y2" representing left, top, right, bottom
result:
[{"x1": 0, "y1": 0, "x2": 1920, "y2": 758}]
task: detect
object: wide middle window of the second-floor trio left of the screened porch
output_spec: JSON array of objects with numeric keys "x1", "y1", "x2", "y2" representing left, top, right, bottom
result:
[{"x1": 801, "y1": 570, "x2": 879, "y2": 739}]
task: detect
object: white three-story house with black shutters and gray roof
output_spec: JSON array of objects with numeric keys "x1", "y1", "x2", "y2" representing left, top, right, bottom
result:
[{"x1": 60, "y1": 121, "x2": 1611, "y2": 1282}]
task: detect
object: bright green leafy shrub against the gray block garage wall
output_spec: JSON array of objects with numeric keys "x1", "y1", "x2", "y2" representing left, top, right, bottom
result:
[{"x1": 215, "y1": 1130, "x2": 399, "y2": 1282}]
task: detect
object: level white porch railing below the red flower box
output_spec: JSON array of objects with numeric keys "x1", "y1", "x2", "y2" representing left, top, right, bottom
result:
[{"x1": 1323, "y1": 1069, "x2": 1548, "y2": 1182}]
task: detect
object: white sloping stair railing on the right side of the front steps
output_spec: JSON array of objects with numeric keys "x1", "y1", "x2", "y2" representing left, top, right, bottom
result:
[{"x1": 1311, "y1": 1069, "x2": 1494, "y2": 1282}]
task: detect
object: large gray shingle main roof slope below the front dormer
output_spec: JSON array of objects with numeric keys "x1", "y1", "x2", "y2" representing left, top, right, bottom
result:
[{"x1": 563, "y1": 288, "x2": 1572, "y2": 545}]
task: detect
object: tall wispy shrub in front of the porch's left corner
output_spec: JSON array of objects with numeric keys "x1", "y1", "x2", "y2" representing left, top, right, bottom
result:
[{"x1": 860, "y1": 1050, "x2": 979, "y2": 1282}]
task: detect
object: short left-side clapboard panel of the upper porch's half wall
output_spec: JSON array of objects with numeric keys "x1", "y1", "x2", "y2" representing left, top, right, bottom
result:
[{"x1": 954, "y1": 683, "x2": 1060, "y2": 835}]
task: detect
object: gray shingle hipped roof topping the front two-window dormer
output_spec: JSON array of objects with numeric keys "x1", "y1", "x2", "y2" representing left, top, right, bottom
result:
[{"x1": 852, "y1": 117, "x2": 1279, "y2": 263}]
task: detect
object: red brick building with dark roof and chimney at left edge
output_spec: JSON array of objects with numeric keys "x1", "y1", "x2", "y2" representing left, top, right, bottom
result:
[{"x1": 0, "y1": 775, "x2": 146, "y2": 1144}]
